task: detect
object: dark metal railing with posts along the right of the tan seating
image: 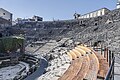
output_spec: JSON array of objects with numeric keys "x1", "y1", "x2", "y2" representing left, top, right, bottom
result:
[{"x1": 93, "y1": 47, "x2": 115, "y2": 80}]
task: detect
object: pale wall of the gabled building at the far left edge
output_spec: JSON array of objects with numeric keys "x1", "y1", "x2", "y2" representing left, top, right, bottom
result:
[{"x1": 0, "y1": 8, "x2": 12, "y2": 22}]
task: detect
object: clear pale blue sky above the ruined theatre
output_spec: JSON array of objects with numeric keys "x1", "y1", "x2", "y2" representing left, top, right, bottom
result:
[{"x1": 0, "y1": 0, "x2": 117, "y2": 21}]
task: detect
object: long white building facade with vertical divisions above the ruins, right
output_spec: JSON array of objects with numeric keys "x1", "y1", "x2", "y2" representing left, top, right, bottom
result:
[{"x1": 79, "y1": 8, "x2": 110, "y2": 19}]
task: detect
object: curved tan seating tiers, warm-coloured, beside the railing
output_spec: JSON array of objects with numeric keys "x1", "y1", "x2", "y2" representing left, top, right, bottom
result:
[{"x1": 58, "y1": 45, "x2": 109, "y2": 80}]
